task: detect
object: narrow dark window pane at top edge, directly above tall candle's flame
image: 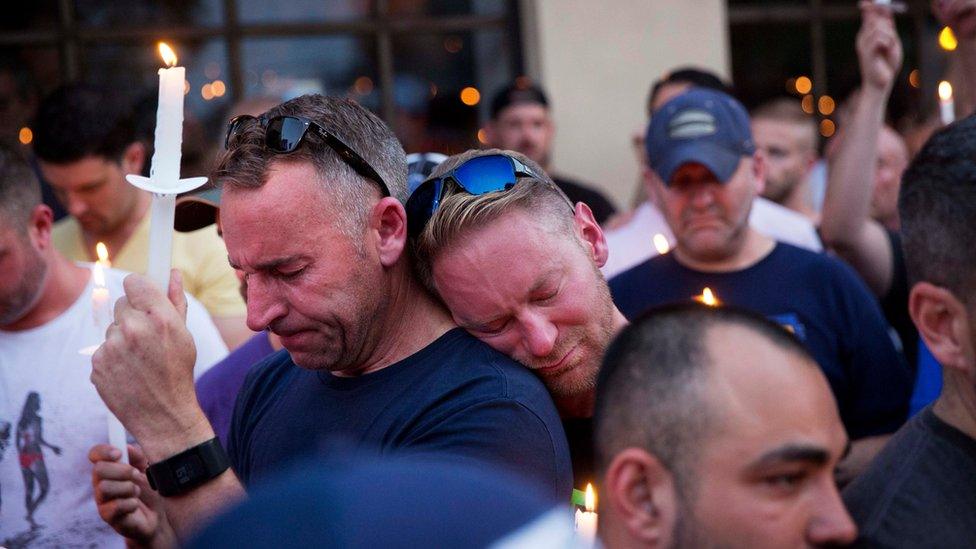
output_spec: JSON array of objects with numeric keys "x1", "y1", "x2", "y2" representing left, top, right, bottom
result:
[{"x1": 75, "y1": 0, "x2": 223, "y2": 27}]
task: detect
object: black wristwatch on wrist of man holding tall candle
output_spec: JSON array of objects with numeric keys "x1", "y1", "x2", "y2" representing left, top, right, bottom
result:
[{"x1": 146, "y1": 437, "x2": 230, "y2": 497}]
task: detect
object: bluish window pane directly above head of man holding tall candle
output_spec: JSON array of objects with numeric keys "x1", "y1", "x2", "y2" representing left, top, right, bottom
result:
[{"x1": 241, "y1": 35, "x2": 380, "y2": 106}]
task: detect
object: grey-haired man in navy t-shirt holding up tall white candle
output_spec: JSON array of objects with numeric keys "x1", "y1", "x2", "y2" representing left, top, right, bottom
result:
[{"x1": 92, "y1": 95, "x2": 572, "y2": 542}]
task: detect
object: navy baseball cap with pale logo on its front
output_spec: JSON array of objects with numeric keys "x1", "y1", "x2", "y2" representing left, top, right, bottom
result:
[{"x1": 644, "y1": 88, "x2": 756, "y2": 184}]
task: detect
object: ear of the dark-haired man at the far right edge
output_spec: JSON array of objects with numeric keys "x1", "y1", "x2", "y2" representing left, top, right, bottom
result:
[{"x1": 908, "y1": 282, "x2": 972, "y2": 370}]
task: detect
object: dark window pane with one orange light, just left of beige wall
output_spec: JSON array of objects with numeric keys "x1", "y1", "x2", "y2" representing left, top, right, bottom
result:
[{"x1": 393, "y1": 31, "x2": 516, "y2": 154}]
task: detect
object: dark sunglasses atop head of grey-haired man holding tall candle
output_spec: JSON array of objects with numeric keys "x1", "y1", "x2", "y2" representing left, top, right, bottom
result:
[{"x1": 224, "y1": 114, "x2": 390, "y2": 196}]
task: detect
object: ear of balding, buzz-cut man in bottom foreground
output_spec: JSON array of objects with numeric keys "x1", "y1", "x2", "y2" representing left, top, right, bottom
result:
[{"x1": 601, "y1": 448, "x2": 678, "y2": 547}]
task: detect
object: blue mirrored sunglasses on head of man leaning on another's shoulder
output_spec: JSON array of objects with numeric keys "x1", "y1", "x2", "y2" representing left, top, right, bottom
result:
[{"x1": 406, "y1": 154, "x2": 560, "y2": 237}]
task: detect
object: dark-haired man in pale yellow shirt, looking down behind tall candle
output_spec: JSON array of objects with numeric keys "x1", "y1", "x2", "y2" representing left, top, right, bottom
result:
[{"x1": 33, "y1": 85, "x2": 251, "y2": 347}]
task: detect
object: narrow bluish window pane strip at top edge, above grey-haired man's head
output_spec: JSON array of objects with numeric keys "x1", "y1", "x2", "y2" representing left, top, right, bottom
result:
[{"x1": 237, "y1": 0, "x2": 371, "y2": 23}]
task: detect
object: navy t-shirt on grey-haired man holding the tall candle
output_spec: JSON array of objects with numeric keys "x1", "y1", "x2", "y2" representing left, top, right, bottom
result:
[{"x1": 228, "y1": 329, "x2": 573, "y2": 501}]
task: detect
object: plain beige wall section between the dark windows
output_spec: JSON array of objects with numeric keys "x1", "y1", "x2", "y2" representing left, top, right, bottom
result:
[{"x1": 521, "y1": 0, "x2": 730, "y2": 210}]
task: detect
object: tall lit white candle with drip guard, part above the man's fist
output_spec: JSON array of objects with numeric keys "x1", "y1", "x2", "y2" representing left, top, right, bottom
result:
[{"x1": 125, "y1": 42, "x2": 207, "y2": 292}]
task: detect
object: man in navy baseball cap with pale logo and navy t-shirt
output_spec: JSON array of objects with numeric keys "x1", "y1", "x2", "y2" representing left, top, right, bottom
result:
[{"x1": 610, "y1": 89, "x2": 911, "y2": 480}]
